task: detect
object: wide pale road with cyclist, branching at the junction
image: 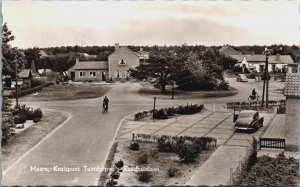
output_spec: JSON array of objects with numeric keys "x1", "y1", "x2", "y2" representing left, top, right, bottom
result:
[{"x1": 2, "y1": 80, "x2": 283, "y2": 186}]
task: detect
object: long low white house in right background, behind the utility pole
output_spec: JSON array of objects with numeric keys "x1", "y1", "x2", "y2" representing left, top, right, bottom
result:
[{"x1": 230, "y1": 54, "x2": 299, "y2": 73}]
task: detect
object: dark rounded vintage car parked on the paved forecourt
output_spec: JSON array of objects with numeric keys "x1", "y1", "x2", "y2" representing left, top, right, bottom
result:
[{"x1": 234, "y1": 110, "x2": 264, "y2": 130}]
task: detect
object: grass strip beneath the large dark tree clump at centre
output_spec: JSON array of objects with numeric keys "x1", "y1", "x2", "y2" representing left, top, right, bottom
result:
[{"x1": 139, "y1": 82, "x2": 238, "y2": 99}]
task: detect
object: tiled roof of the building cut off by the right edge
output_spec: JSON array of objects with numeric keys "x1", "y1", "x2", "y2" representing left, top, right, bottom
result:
[{"x1": 284, "y1": 73, "x2": 300, "y2": 97}]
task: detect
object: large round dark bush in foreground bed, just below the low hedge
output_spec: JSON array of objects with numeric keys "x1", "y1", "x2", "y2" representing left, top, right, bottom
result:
[{"x1": 177, "y1": 143, "x2": 198, "y2": 163}]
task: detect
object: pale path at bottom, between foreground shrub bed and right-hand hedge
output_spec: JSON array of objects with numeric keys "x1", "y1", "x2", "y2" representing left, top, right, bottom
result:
[{"x1": 185, "y1": 146, "x2": 247, "y2": 186}]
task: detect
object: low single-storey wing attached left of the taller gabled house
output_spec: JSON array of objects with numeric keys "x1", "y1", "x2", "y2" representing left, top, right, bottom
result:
[{"x1": 68, "y1": 59, "x2": 108, "y2": 81}]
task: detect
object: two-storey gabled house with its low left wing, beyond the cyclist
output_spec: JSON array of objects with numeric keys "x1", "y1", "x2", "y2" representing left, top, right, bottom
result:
[{"x1": 68, "y1": 44, "x2": 149, "y2": 81}]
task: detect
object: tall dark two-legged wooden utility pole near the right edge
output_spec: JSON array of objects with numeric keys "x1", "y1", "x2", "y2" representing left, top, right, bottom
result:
[{"x1": 261, "y1": 48, "x2": 270, "y2": 108}]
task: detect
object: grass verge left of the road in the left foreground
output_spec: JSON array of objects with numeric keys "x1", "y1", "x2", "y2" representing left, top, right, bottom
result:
[{"x1": 2, "y1": 110, "x2": 67, "y2": 171}]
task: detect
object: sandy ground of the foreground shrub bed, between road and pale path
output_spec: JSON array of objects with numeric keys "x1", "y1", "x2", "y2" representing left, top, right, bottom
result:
[{"x1": 103, "y1": 141, "x2": 216, "y2": 186}]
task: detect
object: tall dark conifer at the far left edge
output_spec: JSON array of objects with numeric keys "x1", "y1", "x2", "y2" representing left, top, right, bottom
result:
[{"x1": 2, "y1": 23, "x2": 25, "y2": 77}]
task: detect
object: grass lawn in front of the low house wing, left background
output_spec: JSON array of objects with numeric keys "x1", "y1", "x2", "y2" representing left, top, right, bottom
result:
[{"x1": 21, "y1": 84, "x2": 110, "y2": 101}]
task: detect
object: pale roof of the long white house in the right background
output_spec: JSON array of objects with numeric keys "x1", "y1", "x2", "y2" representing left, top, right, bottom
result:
[{"x1": 230, "y1": 54, "x2": 294, "y2": 64}]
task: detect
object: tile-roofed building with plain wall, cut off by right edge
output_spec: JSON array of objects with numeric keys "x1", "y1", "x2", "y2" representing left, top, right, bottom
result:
[{"x1": 284, "y1": 73, "x2": 300, "y2": 151}]
